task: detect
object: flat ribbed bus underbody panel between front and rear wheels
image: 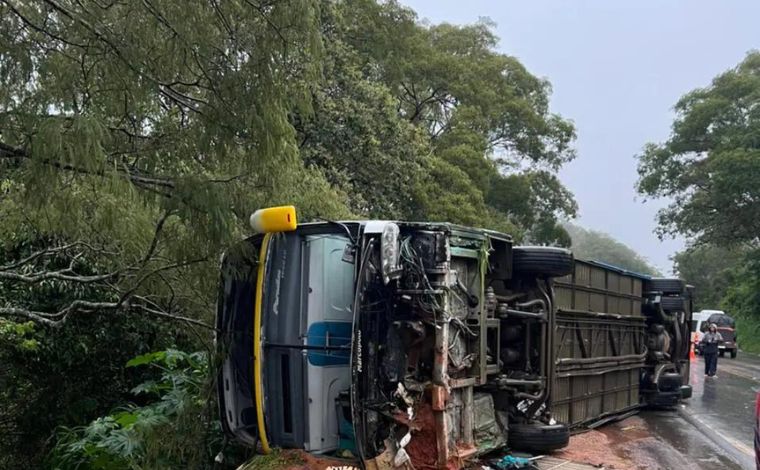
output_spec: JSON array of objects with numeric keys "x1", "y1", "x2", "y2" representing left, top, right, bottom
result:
[{"x1": 552, "y1": 260, "x2": 647, "y2": 428}]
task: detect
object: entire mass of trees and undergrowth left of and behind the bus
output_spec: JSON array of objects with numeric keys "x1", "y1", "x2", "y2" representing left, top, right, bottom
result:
[{"x1": 0, "y1": 0, "x2": 576, "y2": 468}]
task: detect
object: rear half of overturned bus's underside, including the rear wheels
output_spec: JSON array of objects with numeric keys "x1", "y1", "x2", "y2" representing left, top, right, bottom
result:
[{"x1": 552, "y1": 260, "x2": 691, "y2": 422}]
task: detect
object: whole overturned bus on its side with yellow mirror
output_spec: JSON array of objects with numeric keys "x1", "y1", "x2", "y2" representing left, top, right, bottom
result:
[{"x1": 217, "y1": 208, "x2": 690, "y2": 468}]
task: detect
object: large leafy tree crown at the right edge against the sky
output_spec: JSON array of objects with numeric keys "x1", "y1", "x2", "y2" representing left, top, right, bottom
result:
[{"x1": 638, "y1": 52, "x2": 760, "y2": 246}]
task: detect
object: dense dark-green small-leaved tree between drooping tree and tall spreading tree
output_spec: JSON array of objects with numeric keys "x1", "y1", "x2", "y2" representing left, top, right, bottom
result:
[{"x1": 294, "y1": 8, "x2": 430, "y2": 219}]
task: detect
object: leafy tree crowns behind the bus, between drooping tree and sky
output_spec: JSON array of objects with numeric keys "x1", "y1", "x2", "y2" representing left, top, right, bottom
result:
[{"x1": 296, "y1": 0, "x2": 577, "y2": 243}]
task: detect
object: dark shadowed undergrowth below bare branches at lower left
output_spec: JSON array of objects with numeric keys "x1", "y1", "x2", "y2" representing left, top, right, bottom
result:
[{"x1": 0, "y1": 314, "x2": 194, "y2": 468}]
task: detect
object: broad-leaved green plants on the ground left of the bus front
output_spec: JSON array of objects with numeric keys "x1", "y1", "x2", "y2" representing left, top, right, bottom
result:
[{"x1": 49, "y1": 349, "x2": 220, "y2": 469}]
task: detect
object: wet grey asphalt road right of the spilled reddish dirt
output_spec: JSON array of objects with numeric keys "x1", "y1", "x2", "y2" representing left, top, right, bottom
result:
[{"x1": 672, "y1": 352, "x2": 760, "y2": 469}]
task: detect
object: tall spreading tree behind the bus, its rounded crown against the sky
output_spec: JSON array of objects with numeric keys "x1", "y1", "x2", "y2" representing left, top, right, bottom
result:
[{"x1": 332, "y1": 0, "x2": 577, "y2": 243}]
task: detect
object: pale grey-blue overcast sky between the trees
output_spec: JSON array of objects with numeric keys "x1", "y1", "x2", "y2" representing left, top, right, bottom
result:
[{"x1": 401, "y1": 0, "x2": 760, "y2": 273}]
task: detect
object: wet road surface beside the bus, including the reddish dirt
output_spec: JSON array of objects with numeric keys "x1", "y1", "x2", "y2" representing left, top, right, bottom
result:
[{"x1": 558, "y1": 353, "x2": 760, "y2": 470}]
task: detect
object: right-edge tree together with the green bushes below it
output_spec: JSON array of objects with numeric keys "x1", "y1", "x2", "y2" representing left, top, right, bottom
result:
[{"x1": 638, "y1": 52, "x2": 760, "y2": 351}]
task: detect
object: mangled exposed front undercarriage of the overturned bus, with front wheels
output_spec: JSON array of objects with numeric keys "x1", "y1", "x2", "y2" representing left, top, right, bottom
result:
[{"x1": 351, "y1": 224, "x2": 572, "y2": 468}]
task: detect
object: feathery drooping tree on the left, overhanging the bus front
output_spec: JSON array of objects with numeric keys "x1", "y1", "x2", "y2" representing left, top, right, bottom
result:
[{"x1": 0, "y1": 0, "x2": 345, "y2": 325}]
